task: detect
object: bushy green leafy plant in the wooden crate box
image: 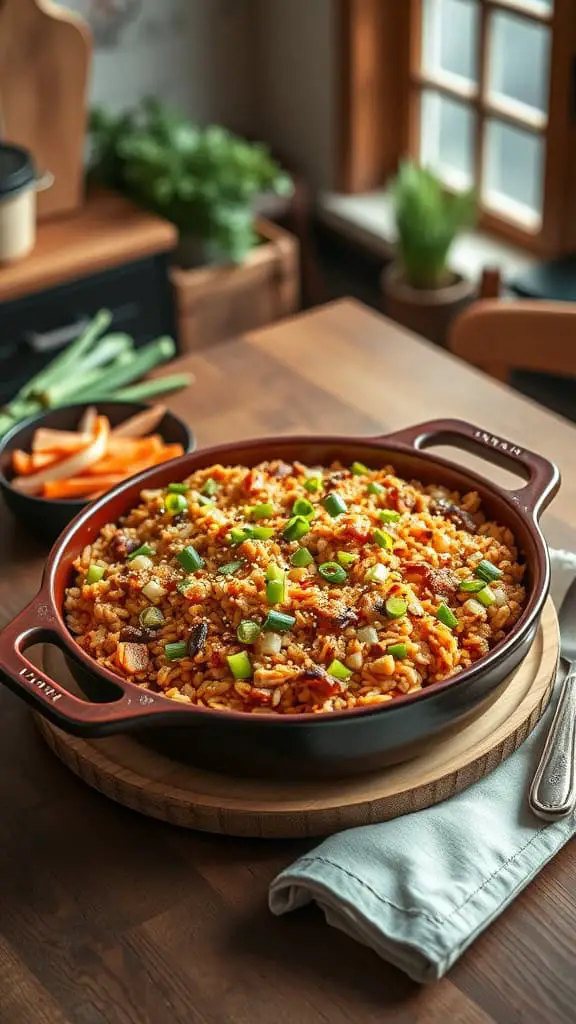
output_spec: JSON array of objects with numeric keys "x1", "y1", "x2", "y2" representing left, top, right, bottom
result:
[{"x1": 89, "y1": 99, "x2": 292, "y2": 262}]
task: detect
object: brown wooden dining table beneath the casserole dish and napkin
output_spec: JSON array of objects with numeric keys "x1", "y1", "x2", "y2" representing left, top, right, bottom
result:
[{"x1": 0, "y1": 300, "x2": 576, "y2": 1024}]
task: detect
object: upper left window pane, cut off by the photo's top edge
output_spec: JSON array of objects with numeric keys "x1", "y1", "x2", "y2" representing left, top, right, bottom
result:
[{"x1": 420, "y1": 0, "x2": 479, "y2": 82}]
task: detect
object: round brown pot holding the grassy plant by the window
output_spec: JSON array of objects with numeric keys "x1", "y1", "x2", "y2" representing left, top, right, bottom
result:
[{"x1": 381, "y1": 263, "x2": 476, "y2": 345}]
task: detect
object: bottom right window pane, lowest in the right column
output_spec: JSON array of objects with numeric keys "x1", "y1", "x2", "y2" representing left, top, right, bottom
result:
[{"x1": 483, "y1": 119, "x2": 544, "y2": 228}]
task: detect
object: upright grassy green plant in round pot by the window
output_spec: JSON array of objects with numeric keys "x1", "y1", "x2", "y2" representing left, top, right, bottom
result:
[{"x1": 385, "y1": 161, "x2": 477, "y2": 289}]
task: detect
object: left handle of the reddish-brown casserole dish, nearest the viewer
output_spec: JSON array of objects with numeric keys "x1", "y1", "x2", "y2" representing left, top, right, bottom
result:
[{"x1": 0, "y1": 593, "x2": 170, "y2": 736}]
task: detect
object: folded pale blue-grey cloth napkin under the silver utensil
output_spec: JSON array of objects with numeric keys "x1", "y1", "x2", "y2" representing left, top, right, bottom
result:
[{"x1": 270, "y1": 551, "x2": 576, "y2": 982}]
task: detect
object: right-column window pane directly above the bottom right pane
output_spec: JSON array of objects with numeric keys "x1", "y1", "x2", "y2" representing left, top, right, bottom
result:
[{"x1": 488, "y1": 11, "x2": 550, "y2": 113}]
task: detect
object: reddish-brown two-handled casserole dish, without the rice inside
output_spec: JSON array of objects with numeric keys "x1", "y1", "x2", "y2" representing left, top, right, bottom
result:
[{"x1": 0, "y1": 420, "x2": 560, "y2": 777}]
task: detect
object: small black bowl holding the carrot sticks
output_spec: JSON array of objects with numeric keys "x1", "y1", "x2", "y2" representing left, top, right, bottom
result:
[{"x1": 0, "y1": 401, "x2": 196, "y2": 544}]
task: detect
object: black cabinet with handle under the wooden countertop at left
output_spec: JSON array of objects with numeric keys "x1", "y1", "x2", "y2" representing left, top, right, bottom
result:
[{"x1": 0, "y1": 253, "x2": 177, "y2": 404}]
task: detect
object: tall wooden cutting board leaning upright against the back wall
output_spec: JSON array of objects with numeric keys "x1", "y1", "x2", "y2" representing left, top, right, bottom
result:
[{"x1": 0, "y1": 0, "x2": 92, "y2": 218}]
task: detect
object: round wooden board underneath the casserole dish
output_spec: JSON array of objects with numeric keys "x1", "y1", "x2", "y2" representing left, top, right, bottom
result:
[{"x1": 35, "y1": 600, "x2": 559, "y2": 839}]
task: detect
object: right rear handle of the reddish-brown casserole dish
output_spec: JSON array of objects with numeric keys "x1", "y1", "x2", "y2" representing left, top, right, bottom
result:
[{"x1": 377, "y1": 420, "x2": 560, "y2": 520}]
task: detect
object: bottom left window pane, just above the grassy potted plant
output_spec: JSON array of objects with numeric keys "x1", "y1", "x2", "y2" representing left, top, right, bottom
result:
[{"x1": 420, "y1": 89, "x2": 475, "y2": 188}]
